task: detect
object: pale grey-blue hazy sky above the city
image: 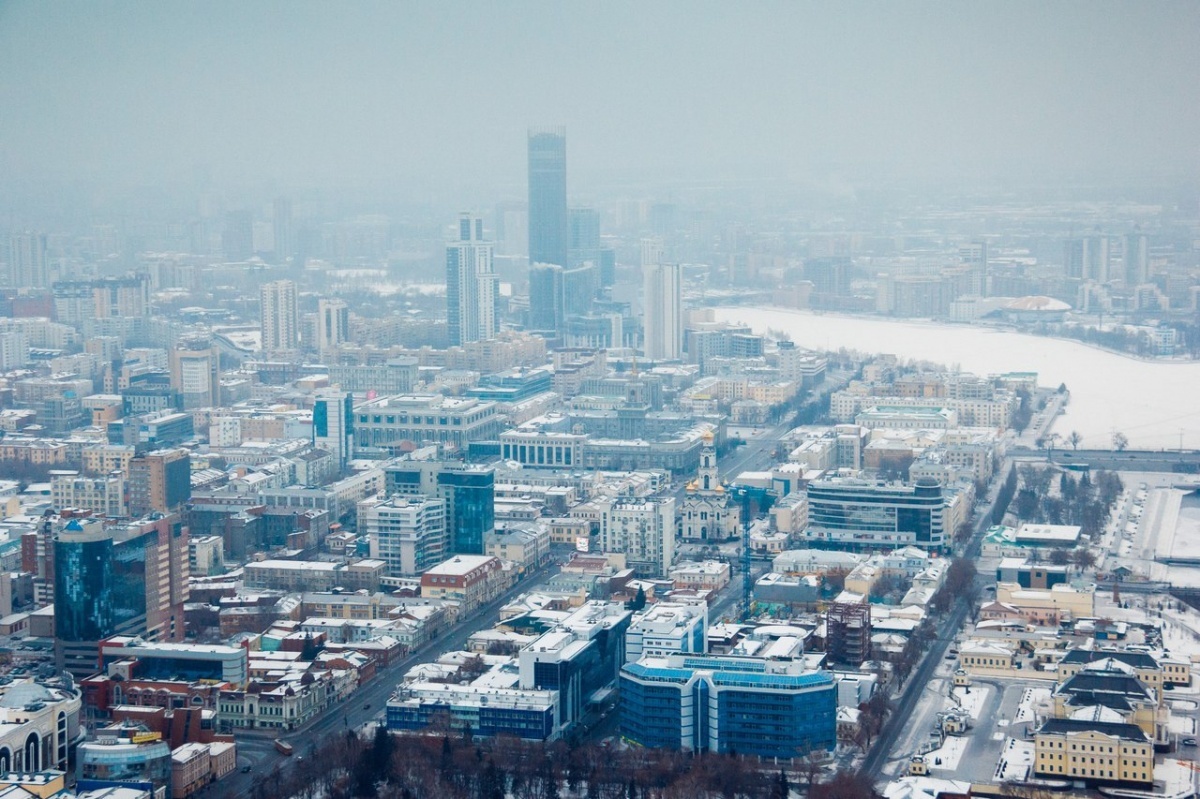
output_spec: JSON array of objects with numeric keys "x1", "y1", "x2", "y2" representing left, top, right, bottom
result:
[{"x1": 0, "y1": 0, "x2": 1200, "y2": 193}]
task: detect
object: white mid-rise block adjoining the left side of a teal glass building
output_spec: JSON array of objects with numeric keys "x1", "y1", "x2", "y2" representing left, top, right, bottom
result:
[{"x1": 359, "y1": 497, "x2": 449, "y2": 577}]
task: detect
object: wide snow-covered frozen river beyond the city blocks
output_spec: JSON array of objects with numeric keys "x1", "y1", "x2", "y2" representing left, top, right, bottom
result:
[{"x1": 716, "y1": 307, "x2": 1200, "y2": 450}]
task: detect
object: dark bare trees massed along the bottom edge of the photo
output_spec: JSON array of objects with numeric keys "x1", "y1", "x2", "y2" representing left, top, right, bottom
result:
[{"x1": 241, "y1": 724, "x2": 882, "y2": 799}]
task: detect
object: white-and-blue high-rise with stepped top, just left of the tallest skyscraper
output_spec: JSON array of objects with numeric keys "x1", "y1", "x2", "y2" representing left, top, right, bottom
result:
[{"x1": 446, "y1": 214, "x2": 496, "y2": 346}]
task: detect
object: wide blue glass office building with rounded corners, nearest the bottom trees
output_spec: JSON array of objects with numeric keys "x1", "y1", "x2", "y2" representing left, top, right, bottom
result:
[{"x1": 620, "y1": 655, "x2": 838, "y2": 757}]
